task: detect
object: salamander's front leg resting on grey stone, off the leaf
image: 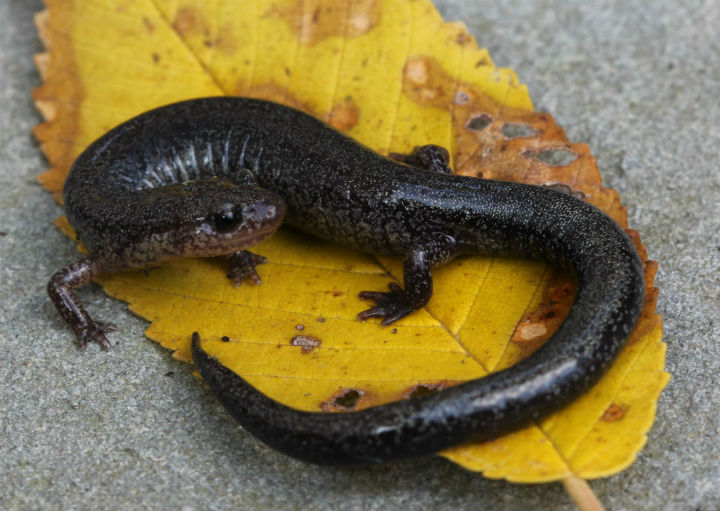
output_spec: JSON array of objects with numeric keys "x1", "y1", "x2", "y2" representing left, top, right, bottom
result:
[{"x1": 47, "y1": 257, "x2": 116, "y2": 350}]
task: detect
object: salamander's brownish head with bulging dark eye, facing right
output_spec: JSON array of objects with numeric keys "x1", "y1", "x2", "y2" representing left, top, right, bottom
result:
[{"x1": 109, "y1": 178, "x2": 285, "y2": 269}]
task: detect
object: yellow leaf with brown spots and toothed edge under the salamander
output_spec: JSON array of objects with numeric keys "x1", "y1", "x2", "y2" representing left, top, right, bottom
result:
[{"x1": 34, "y1": 0, "x2": 669, "y2": 482}]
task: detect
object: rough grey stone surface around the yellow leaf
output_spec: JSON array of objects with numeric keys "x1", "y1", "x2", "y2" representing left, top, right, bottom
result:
[{"x1": 0, "y1": 0, "x2": 720, "y2": 511}]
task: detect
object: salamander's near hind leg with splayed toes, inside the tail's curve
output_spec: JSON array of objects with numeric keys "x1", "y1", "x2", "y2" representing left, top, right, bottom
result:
[{"x1": 358, "y1": 232, "x2": 458, "y2": 325}]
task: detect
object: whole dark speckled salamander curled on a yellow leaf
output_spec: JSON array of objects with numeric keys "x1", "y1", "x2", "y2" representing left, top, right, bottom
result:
[{"x1": 48, "y1": 97, "x2": 645, "y2": 464}]
